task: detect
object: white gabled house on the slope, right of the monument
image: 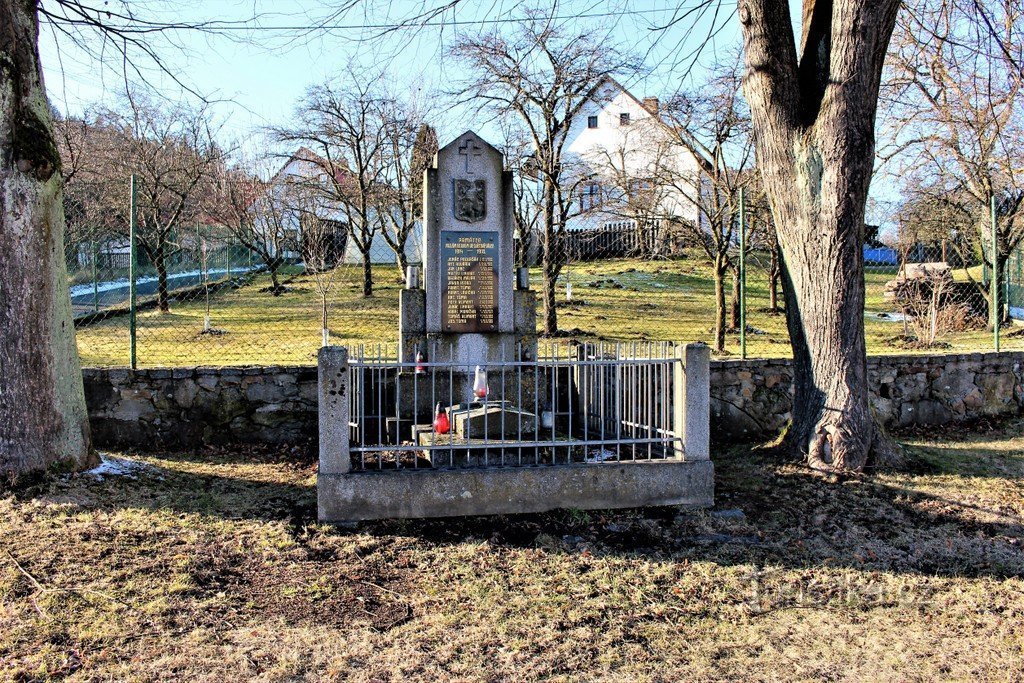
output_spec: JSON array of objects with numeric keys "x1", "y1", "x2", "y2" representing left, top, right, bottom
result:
[{"x1": 564, "y1": 78, "x2": 700, "y2": 230}]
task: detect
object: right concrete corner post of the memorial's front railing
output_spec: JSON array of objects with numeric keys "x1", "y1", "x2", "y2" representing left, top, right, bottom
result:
[{"x1": 672, "y1": 344, "x2": 711, "y2": 460}]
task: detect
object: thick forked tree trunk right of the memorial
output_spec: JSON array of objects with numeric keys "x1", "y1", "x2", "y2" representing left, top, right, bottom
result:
[{"x1": 739, "y1": 0, "x2": 899, "y2": 470}]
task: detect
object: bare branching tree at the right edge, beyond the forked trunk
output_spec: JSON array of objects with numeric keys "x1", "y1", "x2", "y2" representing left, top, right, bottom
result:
[{"x1": 882, "y1": 0, "x2": 1024, "y2": 327}]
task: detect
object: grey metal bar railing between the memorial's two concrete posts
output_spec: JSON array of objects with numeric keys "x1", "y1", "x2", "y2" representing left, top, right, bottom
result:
[{"x1": 348, "y1": 342, "x2": 682, "y2": 471}]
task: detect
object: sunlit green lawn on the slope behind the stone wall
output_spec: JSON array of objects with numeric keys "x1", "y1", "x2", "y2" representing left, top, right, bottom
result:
[{"x1": 78, "y1": 257, "x2": 1020, "y2": 367}]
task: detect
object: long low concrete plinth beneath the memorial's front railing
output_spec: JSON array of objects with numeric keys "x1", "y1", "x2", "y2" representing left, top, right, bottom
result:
[{"x1": 316, "y1": 459, "x2": 715, "y2": 523}]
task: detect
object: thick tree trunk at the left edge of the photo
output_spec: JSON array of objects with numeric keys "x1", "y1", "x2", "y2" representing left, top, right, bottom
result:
[{"x1": 0, "y1": 0, "x2": 95, "y2": 479}]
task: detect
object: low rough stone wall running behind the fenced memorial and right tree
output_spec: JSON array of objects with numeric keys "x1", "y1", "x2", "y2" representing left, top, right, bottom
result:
[{"x1": 83, "y1": 352, "x2": 1024, "y2": 449}]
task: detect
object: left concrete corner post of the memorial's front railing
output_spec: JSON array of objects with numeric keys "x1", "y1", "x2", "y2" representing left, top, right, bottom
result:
[{"x1": 317, "y1": 346, "x2": 351, "y2": 474}]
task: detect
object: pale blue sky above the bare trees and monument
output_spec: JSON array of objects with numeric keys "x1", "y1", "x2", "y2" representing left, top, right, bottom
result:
[{"x1": 40, "y1": 0, "x2": 891, "y2": 228}]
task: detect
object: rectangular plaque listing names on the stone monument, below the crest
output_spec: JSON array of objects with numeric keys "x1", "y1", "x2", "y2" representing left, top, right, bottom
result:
[{"x1": 440, "y1": 230, "x2": 498, "y2": 332}]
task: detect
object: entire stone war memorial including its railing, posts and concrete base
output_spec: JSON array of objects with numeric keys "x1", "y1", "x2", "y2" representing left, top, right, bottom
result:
[{"x1": 317, "y1": 132, "x2": 714, "y2": 521}]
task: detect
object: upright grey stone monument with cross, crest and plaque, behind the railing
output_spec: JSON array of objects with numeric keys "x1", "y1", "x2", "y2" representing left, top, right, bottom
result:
[{"x1": 399, "y1": 132, "x2": 537, "y2": 389}]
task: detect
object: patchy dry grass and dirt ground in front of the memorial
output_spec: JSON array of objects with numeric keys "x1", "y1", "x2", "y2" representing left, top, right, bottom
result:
[{"x1": 0, "y1": 423, "x2": 1024, "y2": 682}]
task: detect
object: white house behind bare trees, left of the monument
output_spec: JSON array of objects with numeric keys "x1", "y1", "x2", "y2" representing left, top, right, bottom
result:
[{"x1": 270, "y1": 146, "x2": 422, "y2": 263}]
